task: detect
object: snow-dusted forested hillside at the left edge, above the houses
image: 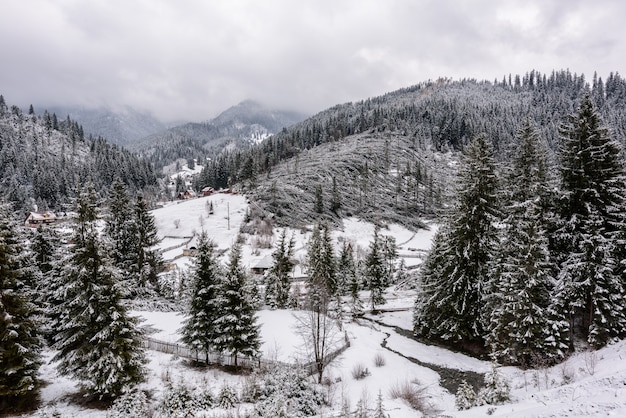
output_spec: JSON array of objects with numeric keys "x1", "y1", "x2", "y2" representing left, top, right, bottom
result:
[{"x1": 0, "y1": 96, "x2": 157, "y2": 211}]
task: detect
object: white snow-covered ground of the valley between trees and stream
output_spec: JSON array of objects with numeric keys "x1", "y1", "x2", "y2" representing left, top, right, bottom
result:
[{"x1": 25, "y1": 194, "x2": 626, "y2": 418}]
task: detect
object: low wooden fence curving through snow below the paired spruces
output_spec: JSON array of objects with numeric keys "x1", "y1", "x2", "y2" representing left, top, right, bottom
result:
[{"x1": 142, "y1": 334, "x2": 350, "y2": 375}]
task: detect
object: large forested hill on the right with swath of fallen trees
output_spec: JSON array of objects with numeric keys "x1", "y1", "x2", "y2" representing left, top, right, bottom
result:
[{"x1": 197, "y1": 71, "x2": 626, "y2": 230}]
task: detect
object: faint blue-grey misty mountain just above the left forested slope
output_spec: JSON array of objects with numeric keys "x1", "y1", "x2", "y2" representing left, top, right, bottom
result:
[{"x1": 48, "y1": 107, "x2": 167, "y2": 146}]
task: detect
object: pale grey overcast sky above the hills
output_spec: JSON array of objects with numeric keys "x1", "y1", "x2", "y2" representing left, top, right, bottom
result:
[{"x1": 0, "y1": 0, "x2": 626, "y2": 121}]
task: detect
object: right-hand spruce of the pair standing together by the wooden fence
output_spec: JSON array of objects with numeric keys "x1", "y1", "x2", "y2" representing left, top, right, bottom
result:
[{"x1": 215, "y1": 244, "x2": 261, "y2": 366}]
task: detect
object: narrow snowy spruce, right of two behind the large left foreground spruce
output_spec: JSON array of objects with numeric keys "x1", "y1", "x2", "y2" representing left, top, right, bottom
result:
[{"x1": 133, "y1": 196, "x2": 163, "y2": 286}]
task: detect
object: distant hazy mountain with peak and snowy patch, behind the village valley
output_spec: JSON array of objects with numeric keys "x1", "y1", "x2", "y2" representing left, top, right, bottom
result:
[{"x1": 131, "y1": 100, "x2": 305, "y2": 169}]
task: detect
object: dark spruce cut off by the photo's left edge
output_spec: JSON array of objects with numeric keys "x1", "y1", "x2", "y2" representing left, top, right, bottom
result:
[{"x1": 0, "y1": 206, "x2": 42, "y2": 413}]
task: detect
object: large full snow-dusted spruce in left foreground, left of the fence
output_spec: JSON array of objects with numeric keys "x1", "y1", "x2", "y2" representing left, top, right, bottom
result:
[{"x1": 54, "y1": 184, "x2": 146, "y2": 399}]
